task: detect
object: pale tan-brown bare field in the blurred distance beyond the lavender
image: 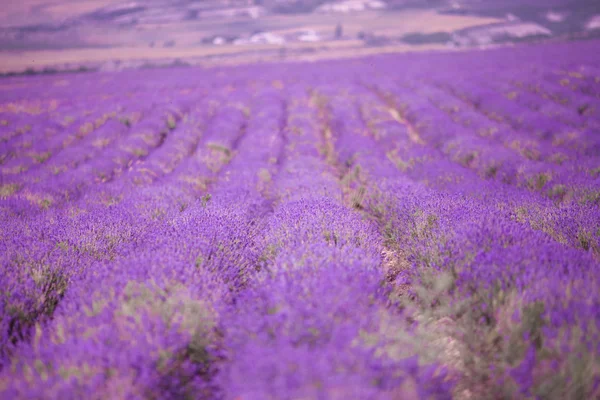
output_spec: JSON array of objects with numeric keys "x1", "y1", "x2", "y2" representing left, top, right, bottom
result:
[{"x1": 0, "y1": 5, "x2": 498, "y2": 73}]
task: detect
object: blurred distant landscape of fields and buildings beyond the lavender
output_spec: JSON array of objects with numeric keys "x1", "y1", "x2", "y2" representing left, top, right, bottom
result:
[{"x1": 0, "y1": 0, "x2": 600, "y2": 75}]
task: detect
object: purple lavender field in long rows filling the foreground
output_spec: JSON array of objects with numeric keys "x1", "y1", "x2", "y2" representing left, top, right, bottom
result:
[{"x1": 0, "y1": 41, "x2": 600, "y2": 400}]
